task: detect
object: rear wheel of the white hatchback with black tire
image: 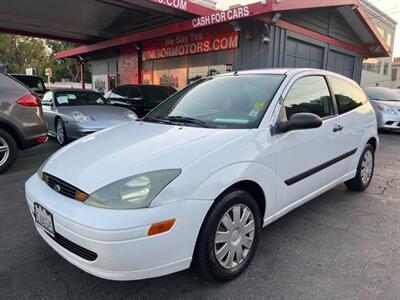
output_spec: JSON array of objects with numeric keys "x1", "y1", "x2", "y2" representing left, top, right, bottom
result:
[{"x1": 345, "y1": 144, "x2": 375, "y2": 192}]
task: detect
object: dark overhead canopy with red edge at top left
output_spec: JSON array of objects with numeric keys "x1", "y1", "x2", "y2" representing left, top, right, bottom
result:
[{"x1": 0, "y1": 0, "x2": 214, "y2": 44}]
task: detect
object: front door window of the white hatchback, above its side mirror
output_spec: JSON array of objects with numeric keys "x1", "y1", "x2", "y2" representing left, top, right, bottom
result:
[{"x1": 284, "y1": 76, "x2": 334, "y2": 119}]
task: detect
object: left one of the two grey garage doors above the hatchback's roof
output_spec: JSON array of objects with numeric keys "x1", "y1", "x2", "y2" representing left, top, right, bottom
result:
[{"x1": 284, "y1": 38, "x2": 324, "y2": 69}]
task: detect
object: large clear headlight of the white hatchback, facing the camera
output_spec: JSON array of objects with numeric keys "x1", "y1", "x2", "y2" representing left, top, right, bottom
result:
[{"x1": 85, "y1": 169, "x2": 182, "y2": 209}]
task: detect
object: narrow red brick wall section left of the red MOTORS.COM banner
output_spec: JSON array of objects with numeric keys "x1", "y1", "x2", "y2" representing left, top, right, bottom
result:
[{"x1": 119, "y1": 45, "x2": 139, "y2": 85}]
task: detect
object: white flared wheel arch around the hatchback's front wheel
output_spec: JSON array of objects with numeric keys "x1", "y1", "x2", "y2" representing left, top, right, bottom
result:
[{"x1": 190, "y1": 162, "x2": 277, "y2": 220}]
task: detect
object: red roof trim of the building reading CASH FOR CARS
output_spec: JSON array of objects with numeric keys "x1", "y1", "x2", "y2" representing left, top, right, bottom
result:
[{"x1": 56, "y1": 0, "x2": 391, "y2": 59}]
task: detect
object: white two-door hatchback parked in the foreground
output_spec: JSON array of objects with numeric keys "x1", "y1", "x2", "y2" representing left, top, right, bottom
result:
[{"x1": 26, "y1": 69, "x2": 378, "y2": 281}]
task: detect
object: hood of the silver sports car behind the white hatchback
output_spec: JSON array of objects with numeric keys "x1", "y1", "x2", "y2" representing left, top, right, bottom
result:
[{"x1": 57, "y1": 105, "x2": 133, "y2": 121}]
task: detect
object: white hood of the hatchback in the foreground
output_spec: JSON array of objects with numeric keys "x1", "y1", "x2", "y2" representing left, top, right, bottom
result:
[{"x1": 43, "y1": 121, "x2": 249, "y2": 193}]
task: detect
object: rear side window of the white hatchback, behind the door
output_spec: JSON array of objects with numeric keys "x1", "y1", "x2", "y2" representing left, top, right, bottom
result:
[{"x1": 329, "y1": 76, "x2": 368, "y2": 114}]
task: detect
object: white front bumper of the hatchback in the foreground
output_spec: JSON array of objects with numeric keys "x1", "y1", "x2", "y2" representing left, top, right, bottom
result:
[{"x1": 26, "y1": 174, "x2": 212, "y2": 280}]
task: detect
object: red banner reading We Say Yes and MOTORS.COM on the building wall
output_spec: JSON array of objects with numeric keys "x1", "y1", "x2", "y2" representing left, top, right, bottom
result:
[{"x1": 142, "y1": 30, "x2": 239, "y2": 60}]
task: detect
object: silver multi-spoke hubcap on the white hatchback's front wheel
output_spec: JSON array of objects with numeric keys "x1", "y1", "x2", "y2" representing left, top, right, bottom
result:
[{"x1": 214, "y1": 204, "x2": 255, "y2": 269}]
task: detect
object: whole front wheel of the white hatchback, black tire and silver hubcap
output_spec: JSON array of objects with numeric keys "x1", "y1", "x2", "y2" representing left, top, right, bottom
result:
[{"x1": 193, "y1": 189, "x2": 262, "y2": 282}]
